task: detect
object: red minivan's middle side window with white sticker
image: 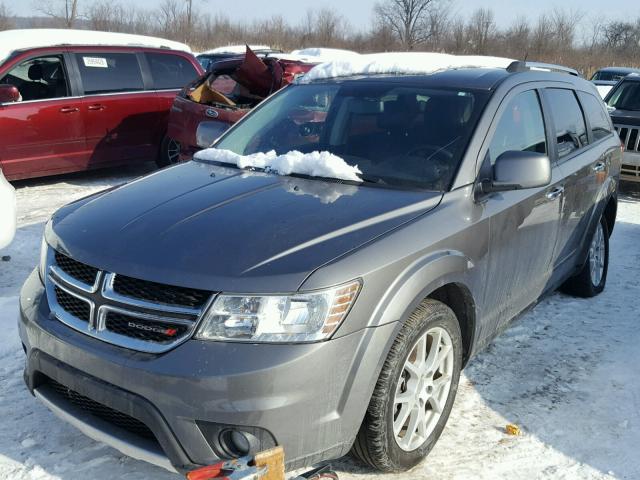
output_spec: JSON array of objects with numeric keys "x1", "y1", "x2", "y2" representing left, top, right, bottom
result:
[{"x1": 76, "y1": 52, "x2": 144, "y2": 95}]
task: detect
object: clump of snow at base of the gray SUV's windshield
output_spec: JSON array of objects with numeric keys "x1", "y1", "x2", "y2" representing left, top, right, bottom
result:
[{"x1": 194, "y1": 148, "x2": 362, "y2": 182}]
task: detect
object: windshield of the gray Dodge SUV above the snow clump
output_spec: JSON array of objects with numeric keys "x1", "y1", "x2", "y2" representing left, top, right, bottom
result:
[{"x1": 215, "y1": 81, "x2": 488, "y2": 191}]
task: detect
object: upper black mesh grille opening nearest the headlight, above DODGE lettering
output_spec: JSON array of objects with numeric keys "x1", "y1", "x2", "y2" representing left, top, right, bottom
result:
[{"x1": 113, "y1": 275, "x2": 211, "y2": 309}]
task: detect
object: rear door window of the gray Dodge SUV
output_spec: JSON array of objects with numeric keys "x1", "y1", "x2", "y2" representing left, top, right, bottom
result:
[{"x1": 545, "y1": 88, "x2": 589, "y2": 158}]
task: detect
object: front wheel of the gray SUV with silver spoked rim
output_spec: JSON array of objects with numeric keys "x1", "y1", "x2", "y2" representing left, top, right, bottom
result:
[{"x1": 351, "y1": 299, "x2": 462, "y2": 472}]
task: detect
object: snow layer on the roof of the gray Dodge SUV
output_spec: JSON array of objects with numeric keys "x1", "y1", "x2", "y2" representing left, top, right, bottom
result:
[{"x1": 299, "y1": 52, "x2": 513, "y2": 83}]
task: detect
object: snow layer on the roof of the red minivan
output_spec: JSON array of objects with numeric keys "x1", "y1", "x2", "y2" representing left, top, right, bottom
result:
[{"x1": 0, "y1": 28, "x2": 191, "y2": 61}]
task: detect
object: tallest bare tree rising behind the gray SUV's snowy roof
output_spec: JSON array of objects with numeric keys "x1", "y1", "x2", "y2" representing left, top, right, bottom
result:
[{"x1": 374, "y1": 0, "x2": 442, "y2": 50}]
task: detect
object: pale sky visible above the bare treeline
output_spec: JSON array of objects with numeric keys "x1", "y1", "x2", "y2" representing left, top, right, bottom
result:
[{"x1": 10, "y1": 0, "x2": 640, "y2": 28}]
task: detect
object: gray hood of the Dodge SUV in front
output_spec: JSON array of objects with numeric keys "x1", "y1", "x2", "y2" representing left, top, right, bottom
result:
[{"x1": 47, "y1": 161, "x2": 442, "y2": 293}]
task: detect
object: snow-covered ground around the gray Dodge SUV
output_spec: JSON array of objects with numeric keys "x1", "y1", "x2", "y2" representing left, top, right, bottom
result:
[{"x1": 0, "y1": 168, "x2": 640, "y2": 480}]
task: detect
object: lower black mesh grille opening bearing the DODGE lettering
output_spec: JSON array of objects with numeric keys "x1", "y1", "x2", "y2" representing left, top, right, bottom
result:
[{"x1": 105, "y1": 312, "x2": 188, "y2": 344}]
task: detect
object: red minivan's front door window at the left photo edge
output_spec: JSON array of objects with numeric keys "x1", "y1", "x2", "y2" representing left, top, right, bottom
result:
[{"x1": 0, "y1": 55, "x2": 69, "y2": 101}]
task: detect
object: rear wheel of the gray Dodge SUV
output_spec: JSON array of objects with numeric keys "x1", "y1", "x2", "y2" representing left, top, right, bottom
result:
[{"x1": 561, "y1": 217, "x2": 609, "y2": 298}]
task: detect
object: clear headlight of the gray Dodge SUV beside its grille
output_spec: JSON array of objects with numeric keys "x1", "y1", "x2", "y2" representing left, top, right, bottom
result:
[{"x1": 195, "y1": 280, "x2": 361, "y2": 342}]
